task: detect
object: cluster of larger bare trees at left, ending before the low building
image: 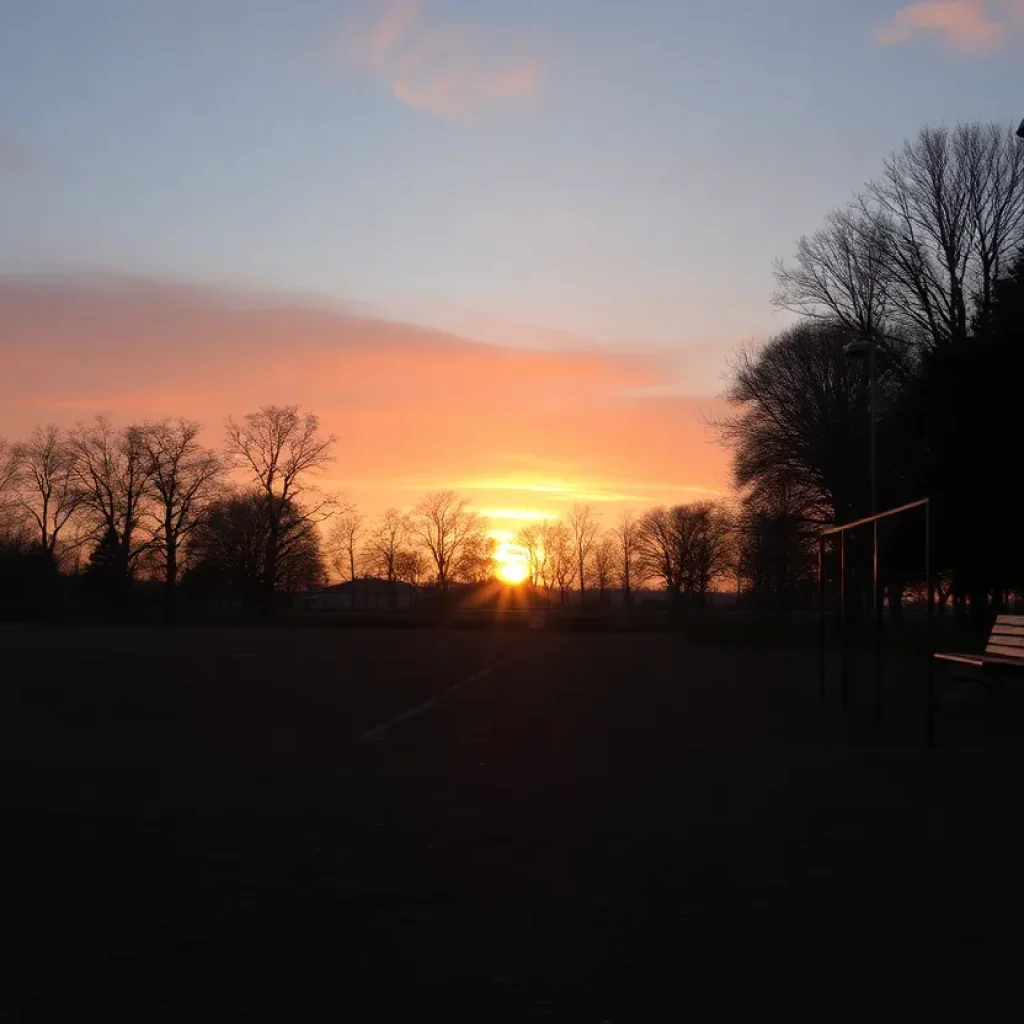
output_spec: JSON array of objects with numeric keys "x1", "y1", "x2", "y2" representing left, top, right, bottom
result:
[{"x1": 0, "y1": 406, "x2": 335, "y2": 608}]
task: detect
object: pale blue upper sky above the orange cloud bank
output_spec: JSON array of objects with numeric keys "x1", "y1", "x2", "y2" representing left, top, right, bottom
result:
[{"x1": 0, "y1": 0, "x2": 1024, "y2": 393}]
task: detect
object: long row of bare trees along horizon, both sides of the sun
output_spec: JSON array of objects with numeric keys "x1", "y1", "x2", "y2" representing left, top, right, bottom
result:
[{"x1": 0, "y1": 406, "x2": 753, "y2": 613}]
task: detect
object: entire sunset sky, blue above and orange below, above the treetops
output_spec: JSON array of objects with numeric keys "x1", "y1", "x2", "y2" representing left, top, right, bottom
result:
[{"x1": 0, "y1": 0, "x2": 1024, "y2": 528}]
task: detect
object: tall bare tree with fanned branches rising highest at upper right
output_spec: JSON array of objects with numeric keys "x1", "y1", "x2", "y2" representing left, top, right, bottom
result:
[{"x1": 774, "y1": 124, "x2": 1024, "y2": 348}]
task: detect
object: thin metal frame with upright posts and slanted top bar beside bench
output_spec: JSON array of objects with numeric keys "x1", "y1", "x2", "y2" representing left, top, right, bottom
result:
[{"x1": 818, "y1": 498, "x2": 935, "y2": 743}]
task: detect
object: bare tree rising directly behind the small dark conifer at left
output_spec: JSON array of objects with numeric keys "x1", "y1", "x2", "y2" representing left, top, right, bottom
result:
[{"x1": 70, "y1": 416, "x2": 154, "y2": 581}]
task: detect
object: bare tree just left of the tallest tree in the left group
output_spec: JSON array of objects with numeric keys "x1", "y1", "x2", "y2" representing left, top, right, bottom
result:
[{"x1": 141, "y1": 419, "x2": 223, "y2": 608}]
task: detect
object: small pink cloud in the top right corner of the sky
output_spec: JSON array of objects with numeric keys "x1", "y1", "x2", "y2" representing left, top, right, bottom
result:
[{"x1": 874, "y1": 0, "x2": 1024, "y2": 53}]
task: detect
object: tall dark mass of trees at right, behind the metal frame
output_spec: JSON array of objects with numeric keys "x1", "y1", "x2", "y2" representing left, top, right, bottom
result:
[{"x1": 718, "y1": 124, "x2": 1024, "y2": 616}]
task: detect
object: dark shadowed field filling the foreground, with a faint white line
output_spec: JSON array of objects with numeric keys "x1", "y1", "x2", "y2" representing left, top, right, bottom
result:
[{"x1": 0, "y1": 629, "x2": 1024, "y2": 1024}]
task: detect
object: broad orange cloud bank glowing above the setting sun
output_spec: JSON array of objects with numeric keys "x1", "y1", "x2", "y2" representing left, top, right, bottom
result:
[{"x1": 0, "y1": 276, "x2": 728, "y2": 524}]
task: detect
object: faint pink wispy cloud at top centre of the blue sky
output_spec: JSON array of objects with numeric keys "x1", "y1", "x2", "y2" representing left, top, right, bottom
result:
[{"x1": 346, "y1": 0, "x2": 543, "y2": 118}]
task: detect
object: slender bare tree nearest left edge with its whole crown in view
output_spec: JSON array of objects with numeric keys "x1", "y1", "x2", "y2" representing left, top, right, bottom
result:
[{"x1": 14, "y1": 424, "x2": 80, "y2": 555}]
